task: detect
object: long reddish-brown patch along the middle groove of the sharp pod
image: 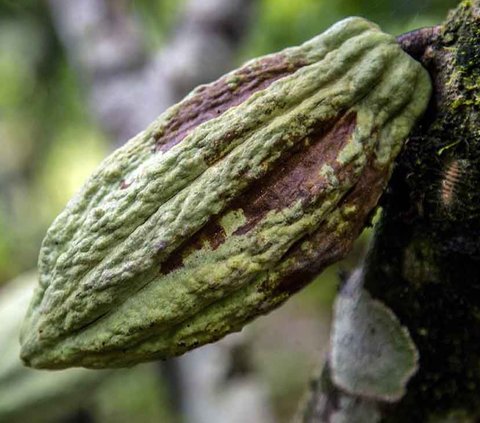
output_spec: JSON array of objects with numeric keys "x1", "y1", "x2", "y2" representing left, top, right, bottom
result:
[{"x1": 161, "y1": 112, "x2": 356, "y2": 274}]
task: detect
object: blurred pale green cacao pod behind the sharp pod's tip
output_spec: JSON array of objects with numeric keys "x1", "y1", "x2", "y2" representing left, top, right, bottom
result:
[{"x1": 0, "y1": 272, "x2": 109, "y2": 423}]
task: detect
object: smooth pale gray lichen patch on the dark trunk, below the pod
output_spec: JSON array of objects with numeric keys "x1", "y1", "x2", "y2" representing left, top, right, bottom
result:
[{"x1": 329, "y1": 271, "x2": 418, "y2": 402}]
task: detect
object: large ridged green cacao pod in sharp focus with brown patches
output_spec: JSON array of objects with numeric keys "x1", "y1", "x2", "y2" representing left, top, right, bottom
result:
[{"x1": 22, "y1": 18, "x2": 431, "y2": 368}]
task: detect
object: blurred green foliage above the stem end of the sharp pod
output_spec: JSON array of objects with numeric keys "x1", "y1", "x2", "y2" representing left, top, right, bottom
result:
[{"x1": 244, "y1": 0, "x2": 458, "y2": 57}]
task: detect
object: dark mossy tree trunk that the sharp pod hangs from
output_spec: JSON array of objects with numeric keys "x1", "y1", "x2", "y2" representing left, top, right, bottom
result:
[{"x1": 301, "y1": 0, "x2": 480, "y2": 422}]
